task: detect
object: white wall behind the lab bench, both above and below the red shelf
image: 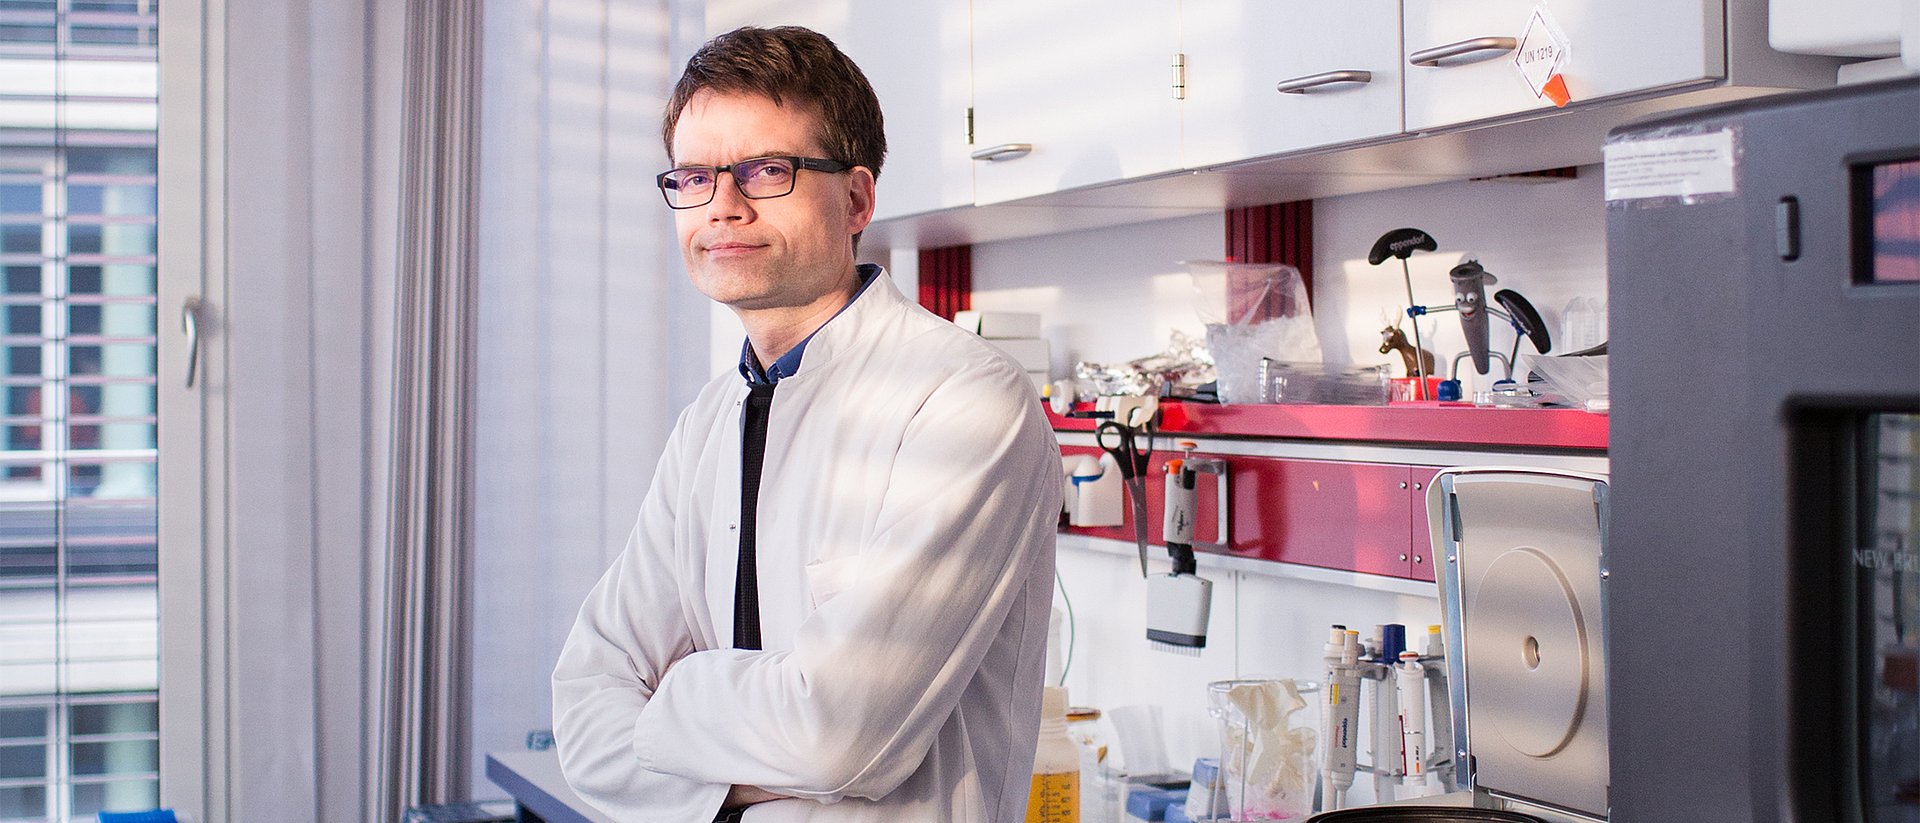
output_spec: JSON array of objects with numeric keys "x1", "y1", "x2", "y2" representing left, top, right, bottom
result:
[{"x1": 973, "y1": 167, "x2": 1605, "y2": 775}]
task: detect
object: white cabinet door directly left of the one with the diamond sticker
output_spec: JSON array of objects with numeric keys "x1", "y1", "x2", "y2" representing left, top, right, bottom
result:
[{"x1": 1181, "y1": 0, "x2": 1405, "y2": 169}]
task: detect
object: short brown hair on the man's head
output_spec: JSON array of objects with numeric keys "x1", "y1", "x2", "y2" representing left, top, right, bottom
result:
[{"x1": 660, "y1": 25, "x2": 887, "y2": 178}]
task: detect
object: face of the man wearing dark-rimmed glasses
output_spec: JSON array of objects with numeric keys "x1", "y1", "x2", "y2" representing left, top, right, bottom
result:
[{"x1": 674, "y1": 92, "x2": 874, "y2": 311}]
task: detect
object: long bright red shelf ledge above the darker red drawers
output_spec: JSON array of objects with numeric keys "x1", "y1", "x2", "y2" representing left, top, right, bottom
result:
[{"x1": 1046, "y1": 401, "x2": 1607, "y2": 451}]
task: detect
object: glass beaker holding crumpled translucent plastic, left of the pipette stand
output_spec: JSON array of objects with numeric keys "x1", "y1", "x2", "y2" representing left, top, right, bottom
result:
[{"x1": 1208, "y1": 679, "x2": 1319, "y2": 821}]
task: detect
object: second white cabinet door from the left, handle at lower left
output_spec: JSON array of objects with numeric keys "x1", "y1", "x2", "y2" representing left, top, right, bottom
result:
[{"x1": 973, "y1": 0, "x2": 1181, "y2": 203}]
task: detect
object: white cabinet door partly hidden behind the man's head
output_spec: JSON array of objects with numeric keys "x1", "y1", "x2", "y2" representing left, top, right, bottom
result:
[{"x1": 707, "y1": 0, "x2": 973, "y2": 221}]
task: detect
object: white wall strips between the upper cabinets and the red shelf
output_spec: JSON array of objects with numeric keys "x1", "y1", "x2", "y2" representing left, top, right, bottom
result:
[{"x1": 973, "y1": 167, "x2": 1607, "y2": 395}]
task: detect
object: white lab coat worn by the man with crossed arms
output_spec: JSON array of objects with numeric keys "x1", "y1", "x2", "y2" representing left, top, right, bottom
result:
[{"x1": 553, "y1": 272, "x2": 1060, "y2": 823}]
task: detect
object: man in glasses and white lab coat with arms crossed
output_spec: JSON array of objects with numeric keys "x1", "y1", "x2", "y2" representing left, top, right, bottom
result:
[{"x1": 553, "y1": 29, "x2": 1060, "y2": 823}]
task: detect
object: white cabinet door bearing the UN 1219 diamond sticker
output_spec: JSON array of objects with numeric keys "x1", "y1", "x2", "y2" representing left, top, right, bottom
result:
[{"x1": 1404, "y1": 0, "x2": 1726, "y2": 132}]
